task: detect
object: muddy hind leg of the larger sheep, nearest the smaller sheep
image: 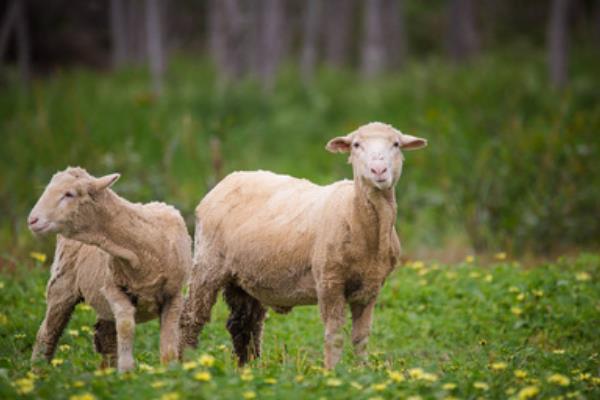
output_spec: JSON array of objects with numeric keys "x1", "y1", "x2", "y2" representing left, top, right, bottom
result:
[{"x1": 179, "y1": 266, "x2": 224, "y2": 355}]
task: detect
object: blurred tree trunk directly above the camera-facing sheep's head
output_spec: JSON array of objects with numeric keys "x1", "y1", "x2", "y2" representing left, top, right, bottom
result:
[{"x1": 361, "y1": 0, "x2": 386, "y2": 77}]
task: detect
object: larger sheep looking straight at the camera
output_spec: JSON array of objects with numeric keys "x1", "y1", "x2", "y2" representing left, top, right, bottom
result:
[{"x1": 180, "y1": 122, "x2": 427, "y2": 369}]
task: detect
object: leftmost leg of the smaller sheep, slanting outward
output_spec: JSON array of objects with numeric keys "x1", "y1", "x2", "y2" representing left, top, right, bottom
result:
[{"x1": 31, "y1": 277, "x2": 81, "y2": 362}]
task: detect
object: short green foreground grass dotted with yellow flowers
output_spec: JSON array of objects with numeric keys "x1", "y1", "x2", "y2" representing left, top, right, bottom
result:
[{"x1": 0, "y1": 254, "x2": 600, "y2": 399}]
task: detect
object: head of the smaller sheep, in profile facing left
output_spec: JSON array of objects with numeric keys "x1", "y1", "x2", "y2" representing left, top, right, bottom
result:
[{"x1": 27, "y1": 167, "x2": 119, "y2": 237}]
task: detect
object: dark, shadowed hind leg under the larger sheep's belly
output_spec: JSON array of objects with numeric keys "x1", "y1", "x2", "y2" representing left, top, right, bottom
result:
[{"x1": 223, "y1": 283, "x2": 267, "y2": 366}]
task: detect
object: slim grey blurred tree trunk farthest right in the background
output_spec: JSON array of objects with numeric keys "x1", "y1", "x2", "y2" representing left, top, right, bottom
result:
[{"x1": 547, "y1": 0, "x2": 569, "y2": 87}]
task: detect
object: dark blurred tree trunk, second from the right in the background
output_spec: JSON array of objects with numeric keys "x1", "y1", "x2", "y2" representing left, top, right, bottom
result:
[{"x1": 448, "y1": 0, "x2": 479, "y2": 61}]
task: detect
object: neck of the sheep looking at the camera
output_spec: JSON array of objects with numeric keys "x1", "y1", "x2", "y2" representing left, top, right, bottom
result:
[{"x1": 354, "y1": 177, "x2": 397, "y2": 259}]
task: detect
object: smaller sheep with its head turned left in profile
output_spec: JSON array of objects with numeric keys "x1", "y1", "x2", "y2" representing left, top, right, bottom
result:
[{"x1": 28, "y1": 167, "x2": 192, "y2": 372}]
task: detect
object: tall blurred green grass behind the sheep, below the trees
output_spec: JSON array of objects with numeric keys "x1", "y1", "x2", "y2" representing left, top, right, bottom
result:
[{"x1": 0, "y1": 47, "x2": 600, "y2": 256}]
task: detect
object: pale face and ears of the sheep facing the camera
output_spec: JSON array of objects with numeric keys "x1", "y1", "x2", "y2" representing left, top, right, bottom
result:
[{"x1": 326, "y1": 122, "x2": 427, "y2": 190}]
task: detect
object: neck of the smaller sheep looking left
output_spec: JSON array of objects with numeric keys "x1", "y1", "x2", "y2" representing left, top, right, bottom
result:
[{"x1": 73, "y1": 190, "x2": 153, "y2": 270}]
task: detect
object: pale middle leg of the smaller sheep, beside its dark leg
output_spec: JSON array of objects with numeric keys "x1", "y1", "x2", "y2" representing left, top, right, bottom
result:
[{"x1": 102, "y1": 286, "x2": 135, "y2": 372}]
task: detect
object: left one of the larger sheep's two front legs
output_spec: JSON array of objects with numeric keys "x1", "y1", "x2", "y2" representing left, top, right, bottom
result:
[{"x1": 318, "y1": 284, "x2": 346, "y2": 369}]
